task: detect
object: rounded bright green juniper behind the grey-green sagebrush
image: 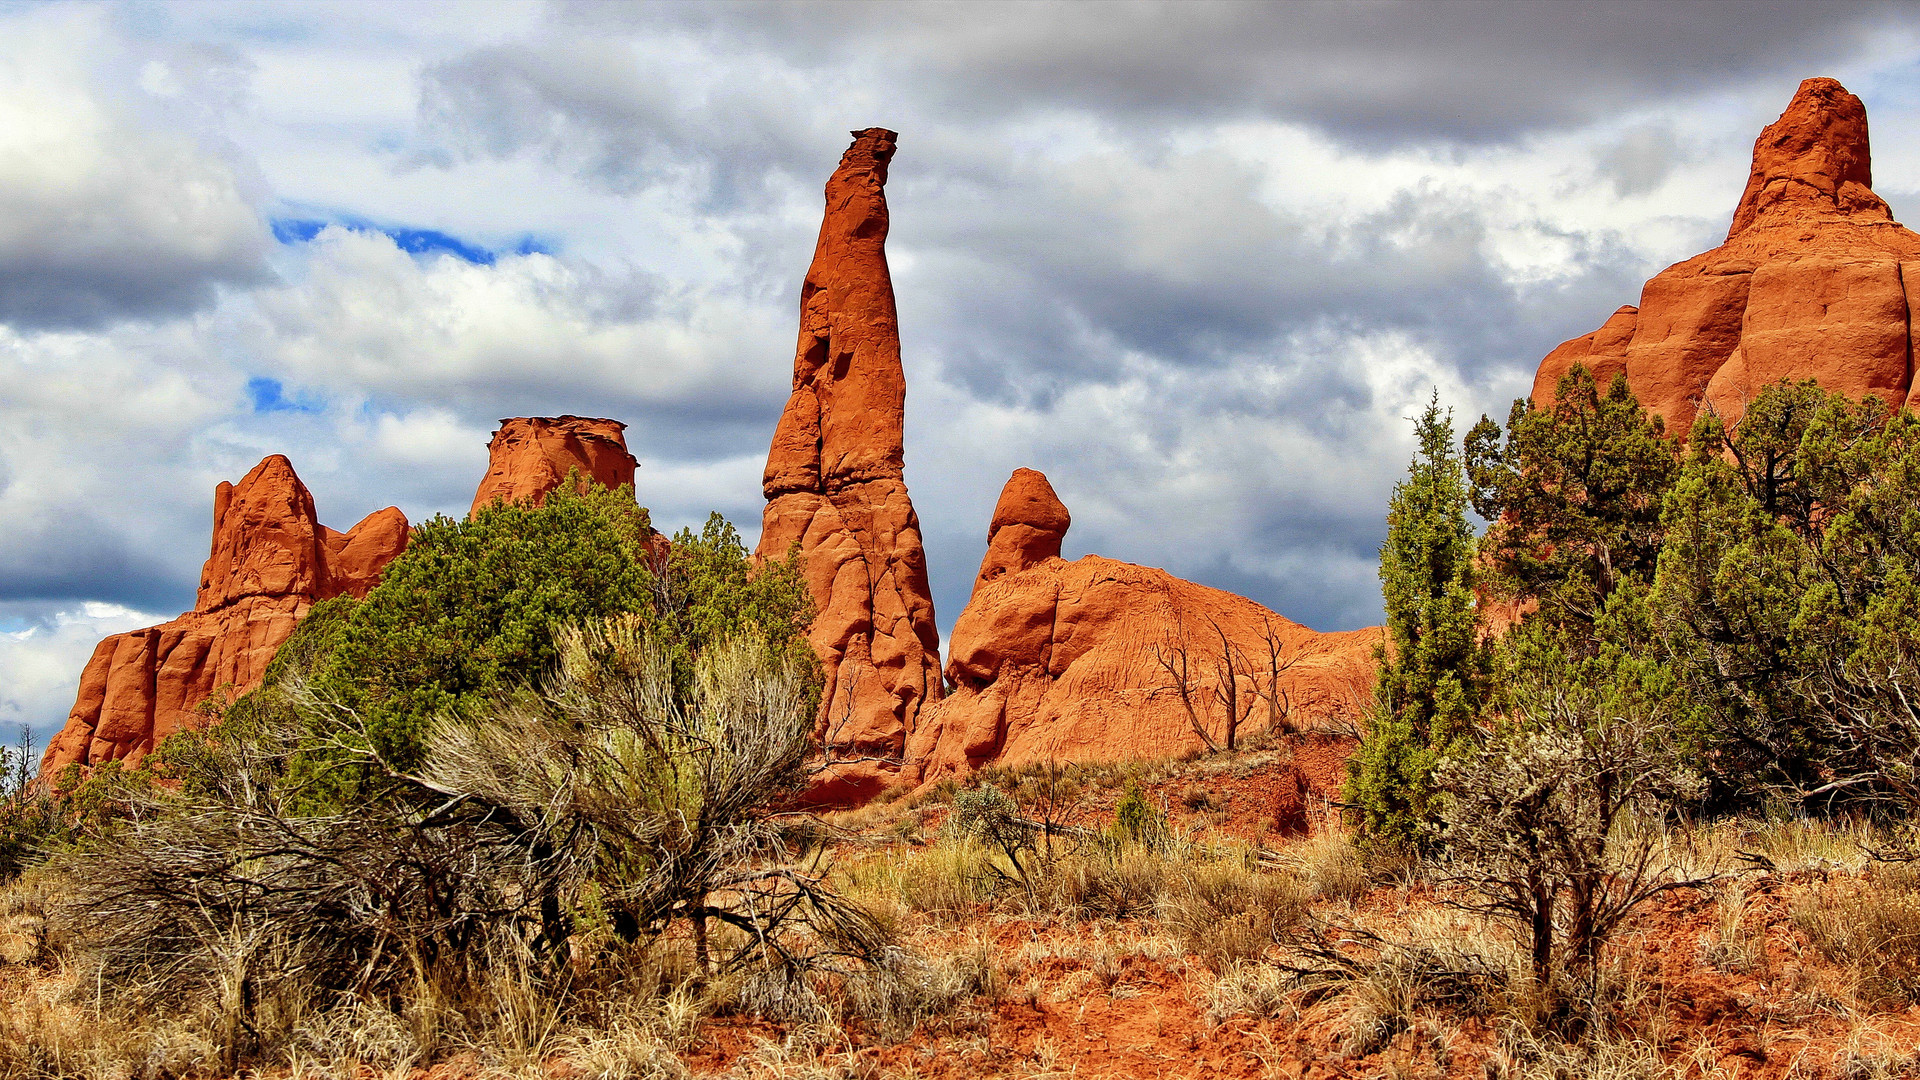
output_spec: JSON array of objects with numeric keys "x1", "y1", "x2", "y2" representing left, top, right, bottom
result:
[{"x1": 217, "y1": 474, "x2": 818, "y2": 805}]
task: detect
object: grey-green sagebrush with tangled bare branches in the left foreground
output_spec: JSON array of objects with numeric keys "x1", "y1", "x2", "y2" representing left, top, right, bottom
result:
[{"x1": 24, "y1": 617, "x2": 921, "y2": 1070}]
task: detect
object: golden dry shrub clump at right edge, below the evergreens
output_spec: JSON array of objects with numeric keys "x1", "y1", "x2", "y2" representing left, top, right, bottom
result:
[{"x1": 1793, "y1": 863, "x2": 1920, "y2": 1009}]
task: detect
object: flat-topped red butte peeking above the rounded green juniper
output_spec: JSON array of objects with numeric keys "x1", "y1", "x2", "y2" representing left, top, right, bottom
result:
[{"x1": 468, "y1": 417, "x2": 637, "y2": 517}]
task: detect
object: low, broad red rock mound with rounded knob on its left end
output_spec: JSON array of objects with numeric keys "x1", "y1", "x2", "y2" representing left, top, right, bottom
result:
[{"x1": 902, "y1": 478, "x2": 1380, "y2": 784}]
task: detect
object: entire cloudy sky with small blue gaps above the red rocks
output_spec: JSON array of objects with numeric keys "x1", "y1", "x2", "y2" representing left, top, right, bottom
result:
[{"x1": 0, "y1": 0, "x2": 1920, "y2": 742}]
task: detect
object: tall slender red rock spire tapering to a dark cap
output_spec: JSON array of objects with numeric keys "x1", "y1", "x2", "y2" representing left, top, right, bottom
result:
[{"x1": 756, "y1": 127, "x2": 941, "y2": 799}]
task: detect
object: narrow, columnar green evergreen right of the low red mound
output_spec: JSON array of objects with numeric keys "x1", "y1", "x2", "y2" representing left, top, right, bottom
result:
[{"x1": 1346, "y1": 394, "x2": 1490, "y2": 846}]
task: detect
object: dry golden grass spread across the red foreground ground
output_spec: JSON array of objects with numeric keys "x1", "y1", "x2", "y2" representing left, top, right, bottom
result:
[{"x1": 22, "y1": 734, "x2": 1920, "y2": 1080}]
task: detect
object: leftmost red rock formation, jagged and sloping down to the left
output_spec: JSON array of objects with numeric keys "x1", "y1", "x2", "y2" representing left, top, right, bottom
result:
[{"x1": 40, "y1": 454, "x2": 409, "y2": 776}]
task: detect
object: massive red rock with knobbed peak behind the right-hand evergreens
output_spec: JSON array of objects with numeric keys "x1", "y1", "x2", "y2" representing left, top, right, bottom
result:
[{"x1": 1532, "y1": 79, "x2": 1920, "y2": 424}]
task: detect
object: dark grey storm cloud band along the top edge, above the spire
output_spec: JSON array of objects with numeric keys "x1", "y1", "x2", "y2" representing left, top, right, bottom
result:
[{"x1": 557, "y1": 0, "x2": 1914, "y2": 144}]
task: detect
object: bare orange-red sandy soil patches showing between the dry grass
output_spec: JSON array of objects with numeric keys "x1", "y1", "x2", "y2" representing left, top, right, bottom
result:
[{"x1": 685, "y1": 738, "x2": 1920, "y2": 1080}]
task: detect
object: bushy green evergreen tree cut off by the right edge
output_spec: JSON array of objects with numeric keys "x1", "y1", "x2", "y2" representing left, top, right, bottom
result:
[{"x1": 1651, "y1": 380, "x2": 1920, "y2": 803}]
